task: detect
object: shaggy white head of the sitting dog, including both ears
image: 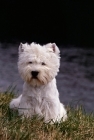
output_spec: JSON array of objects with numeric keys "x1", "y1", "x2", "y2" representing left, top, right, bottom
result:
[{"x1": 18, "y1": 43, "x2": 60, "y2": 86}]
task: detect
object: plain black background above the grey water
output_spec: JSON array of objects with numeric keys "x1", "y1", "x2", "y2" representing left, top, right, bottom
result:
[{"x1": 0, "y1": 0, "x2": 94, "y2": 47}]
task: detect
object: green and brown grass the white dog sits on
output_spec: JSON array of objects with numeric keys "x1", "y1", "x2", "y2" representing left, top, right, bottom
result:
[{"x1": 0, "y1": 92, "x2": 94, "y2": 140}]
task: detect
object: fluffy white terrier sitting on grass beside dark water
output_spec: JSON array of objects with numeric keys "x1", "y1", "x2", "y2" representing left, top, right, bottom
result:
[{"x1": 10, "y1": 43, "x2": 67, "y2": 122}]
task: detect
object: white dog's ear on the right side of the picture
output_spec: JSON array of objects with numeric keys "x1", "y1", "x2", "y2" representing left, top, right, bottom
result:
[{"x1": 45, "y1": 43, "x2": 60, "y2": 55}]
